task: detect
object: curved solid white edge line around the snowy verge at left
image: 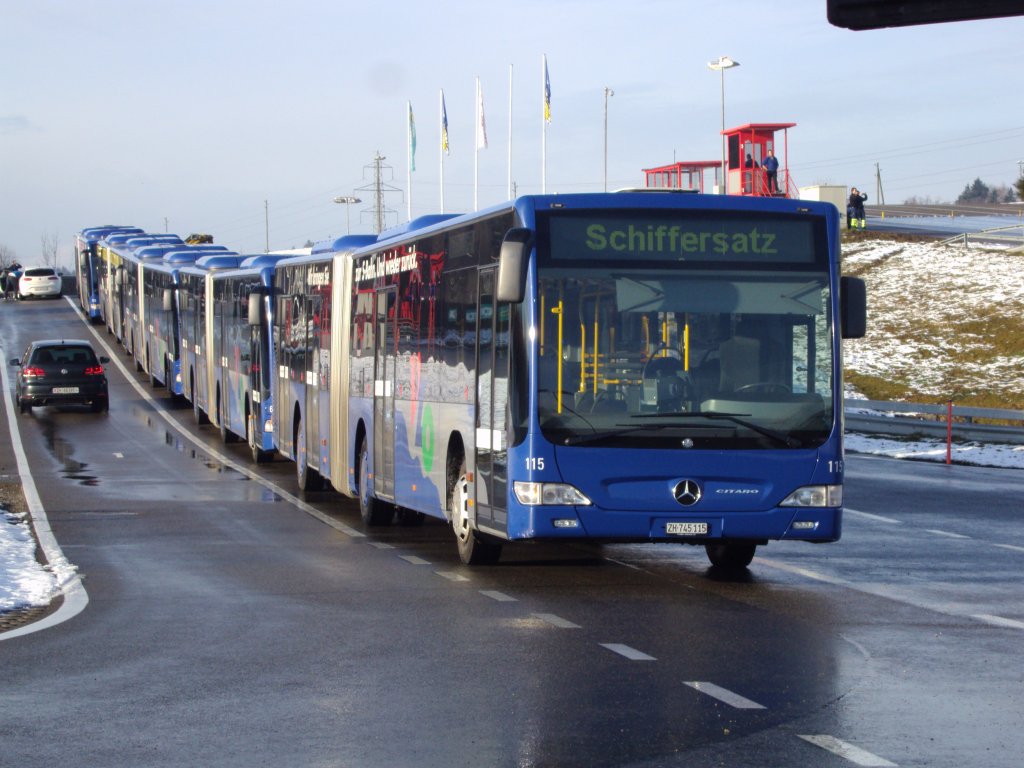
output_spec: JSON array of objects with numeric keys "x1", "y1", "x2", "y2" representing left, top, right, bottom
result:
[{"x1": 0, "y1": 345, "x2": 89, "y2": 640}]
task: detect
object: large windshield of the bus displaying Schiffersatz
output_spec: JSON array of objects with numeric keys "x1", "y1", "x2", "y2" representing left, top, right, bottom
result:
[{"x1": 537, "y1": 210, "x2": 835, "y2": 450}]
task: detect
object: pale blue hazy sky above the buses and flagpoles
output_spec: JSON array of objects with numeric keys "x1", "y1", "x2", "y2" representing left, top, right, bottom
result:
[{"x1": 0, "y1": 0, "x2": 1024, "y2": 266}]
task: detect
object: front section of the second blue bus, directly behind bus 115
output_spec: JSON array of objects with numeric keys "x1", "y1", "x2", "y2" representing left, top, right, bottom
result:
[{"x1": 211, "y1": 254, "x2": 285, "y2": 464}]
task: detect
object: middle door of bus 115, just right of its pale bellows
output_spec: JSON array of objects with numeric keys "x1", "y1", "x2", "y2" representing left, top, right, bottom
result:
[{"x1": 374, "y1": 286, "x2": 398, "y2": 499}]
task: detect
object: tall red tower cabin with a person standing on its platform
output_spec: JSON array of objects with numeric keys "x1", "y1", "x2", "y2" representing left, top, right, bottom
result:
[{"x1": 722, "y1": 123, "x2": 800, "y2": 198}]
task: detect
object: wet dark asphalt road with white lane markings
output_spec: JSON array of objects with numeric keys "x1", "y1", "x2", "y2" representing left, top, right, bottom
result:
[{"x1": 0, "y1": 301, "x2": 1024, "y2": 768}]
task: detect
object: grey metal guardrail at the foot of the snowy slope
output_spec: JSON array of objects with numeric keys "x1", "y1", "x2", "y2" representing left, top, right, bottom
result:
[{"x1": 844, "y1": 399, "x2": 1024, "y2": 444}]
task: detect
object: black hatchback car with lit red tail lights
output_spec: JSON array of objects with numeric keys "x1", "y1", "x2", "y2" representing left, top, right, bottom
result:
[{"x1": 10, "y1": 339, "x2": 110, "y2": 414}]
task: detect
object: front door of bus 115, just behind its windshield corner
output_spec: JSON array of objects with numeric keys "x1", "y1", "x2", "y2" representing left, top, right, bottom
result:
[{"x1": 474, "y1": 268, "x2": 511, "y2": 531}]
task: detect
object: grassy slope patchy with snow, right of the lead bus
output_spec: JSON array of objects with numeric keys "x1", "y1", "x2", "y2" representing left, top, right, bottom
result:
[{"x1": 843, "y1": 232, "x2": 1024, "y2": 409}]
